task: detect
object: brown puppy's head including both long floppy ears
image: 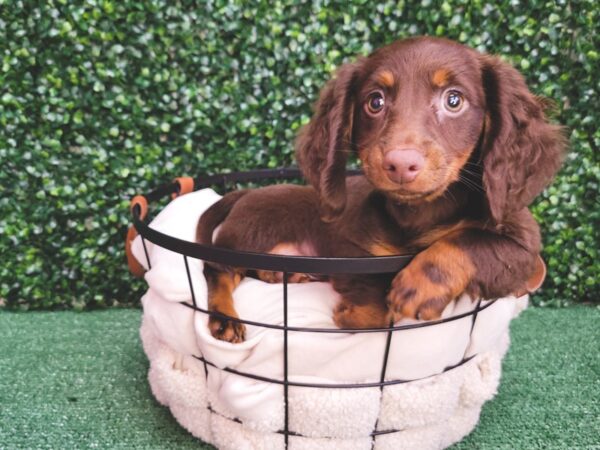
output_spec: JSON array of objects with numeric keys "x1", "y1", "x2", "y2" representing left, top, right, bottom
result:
[{"x1": 297, "y1": 38, "x2": 564, "y2": 222}]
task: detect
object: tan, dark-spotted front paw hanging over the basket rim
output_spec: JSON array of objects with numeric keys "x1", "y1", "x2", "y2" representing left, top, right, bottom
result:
[{"x1": 387, "y1": 263, "x2": 455, "y2": 321}]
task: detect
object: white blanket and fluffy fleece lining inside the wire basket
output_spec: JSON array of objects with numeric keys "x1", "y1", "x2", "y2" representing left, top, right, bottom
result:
[{"x1": 132, "y1": 189, "x2": 527, "y2": 450}]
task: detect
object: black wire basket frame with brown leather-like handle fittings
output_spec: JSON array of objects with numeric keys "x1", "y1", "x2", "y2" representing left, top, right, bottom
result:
[{"x1": 126, "y1": 168, "x2": 495, "y2": 448}]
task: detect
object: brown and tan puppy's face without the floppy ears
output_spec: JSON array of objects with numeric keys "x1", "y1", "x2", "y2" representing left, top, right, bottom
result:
[{"x1": 352, "y1": 39, "x2": 486, "y2": 203}]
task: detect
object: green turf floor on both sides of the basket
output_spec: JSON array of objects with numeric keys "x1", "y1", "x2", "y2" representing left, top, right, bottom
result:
[{"x1": 0, "y1": 306, "x2": 600, "y2": 449}]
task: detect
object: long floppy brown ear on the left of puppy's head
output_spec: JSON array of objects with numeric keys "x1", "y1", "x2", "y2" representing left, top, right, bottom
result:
[{"x1": 296, "y1": 62, "x2": 360, "y2": 222}]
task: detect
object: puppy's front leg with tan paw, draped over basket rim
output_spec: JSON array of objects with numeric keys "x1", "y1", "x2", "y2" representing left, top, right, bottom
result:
[{"x1": 388, "y1": 215, "x2": 540, "y2": 320}]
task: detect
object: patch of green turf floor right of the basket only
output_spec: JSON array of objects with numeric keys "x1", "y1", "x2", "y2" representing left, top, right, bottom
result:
[{"x1": 453, "y1": 306, "x2": 600, "y2": 449}]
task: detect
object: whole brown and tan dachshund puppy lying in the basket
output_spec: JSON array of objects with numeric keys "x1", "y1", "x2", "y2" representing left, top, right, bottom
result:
[{"x1": 197, "y1": 37, "x2": 566, "y2": 342}]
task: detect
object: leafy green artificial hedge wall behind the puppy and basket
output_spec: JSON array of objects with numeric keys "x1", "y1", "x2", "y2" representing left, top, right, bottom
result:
[{"x1": 0, "y1": 0, "x2": 600, "y2": 308}]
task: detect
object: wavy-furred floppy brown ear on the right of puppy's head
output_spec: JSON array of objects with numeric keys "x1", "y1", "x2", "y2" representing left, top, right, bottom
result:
[{"x1": 480, "y1": 55, "x2": 567, "y2": 224}]
